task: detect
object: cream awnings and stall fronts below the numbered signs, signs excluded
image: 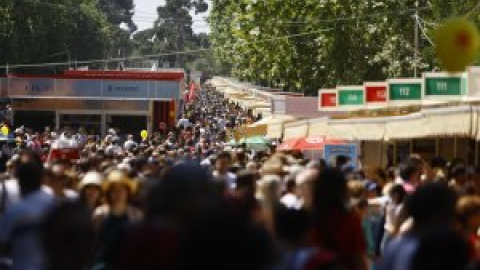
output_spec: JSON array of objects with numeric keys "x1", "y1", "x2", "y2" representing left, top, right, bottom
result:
[{"x1": 236, "y1": 104, "x2": 480, "y2": 166}]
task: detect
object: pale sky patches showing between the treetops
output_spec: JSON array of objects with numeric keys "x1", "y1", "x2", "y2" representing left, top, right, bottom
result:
[{"x1": 133, "y1": 0, "x2": 210, "y2": 33}]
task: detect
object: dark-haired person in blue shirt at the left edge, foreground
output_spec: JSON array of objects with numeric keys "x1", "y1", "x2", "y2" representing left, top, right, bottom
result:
[{"x1": 0, "y1": 153, "x2": 54, "y2": 270}]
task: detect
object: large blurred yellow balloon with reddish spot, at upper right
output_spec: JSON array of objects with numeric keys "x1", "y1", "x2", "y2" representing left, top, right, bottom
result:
[{"x1": 435, "y1": 17, "x2": 479, "y2": 72}]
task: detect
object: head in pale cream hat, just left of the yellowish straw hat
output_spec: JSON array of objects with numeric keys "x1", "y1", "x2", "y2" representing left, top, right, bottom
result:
[{"x1": 78, "y1": 171, "x2": 103, "y2": 214}]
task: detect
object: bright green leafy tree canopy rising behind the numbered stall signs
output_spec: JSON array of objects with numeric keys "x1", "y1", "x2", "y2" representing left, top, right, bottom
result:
[{"x1": 209, "y1": 0, "x2": 478, "y2": 94}]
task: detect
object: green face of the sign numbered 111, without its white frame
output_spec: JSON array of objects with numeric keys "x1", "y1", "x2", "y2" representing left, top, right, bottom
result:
[{"x1": 425, "y1": 77, "x2": 465, "y2": 96}]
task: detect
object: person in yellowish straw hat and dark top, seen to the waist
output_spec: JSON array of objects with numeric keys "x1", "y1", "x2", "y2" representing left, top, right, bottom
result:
[{"x1": 93, "y1": 170, "x2": 143, "y2": 269}]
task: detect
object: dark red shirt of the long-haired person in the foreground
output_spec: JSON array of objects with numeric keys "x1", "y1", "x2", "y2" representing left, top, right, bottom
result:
[{"x1": 313, "y1": 211, "x2": 367, "y2": 269}]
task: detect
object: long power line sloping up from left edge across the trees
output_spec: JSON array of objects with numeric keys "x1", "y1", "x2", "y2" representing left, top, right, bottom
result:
[{"x1": 0, "y1": 28, "x2": 333, "y2": 69}]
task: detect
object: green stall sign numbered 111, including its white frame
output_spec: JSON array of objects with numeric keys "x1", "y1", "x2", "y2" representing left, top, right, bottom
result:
[{"x1": 423, "y1": 73, "x2": 467, "y2": 100}]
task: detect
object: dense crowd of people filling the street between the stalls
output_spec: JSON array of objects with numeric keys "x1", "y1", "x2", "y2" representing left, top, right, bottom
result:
[{"x1": 0, "y1": 86, "x2": 480, "y2": 270}]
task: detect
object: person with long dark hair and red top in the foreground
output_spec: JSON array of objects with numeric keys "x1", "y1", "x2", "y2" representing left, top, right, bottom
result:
[{"x1": 312, "y1": 169, "x2": 367, "y2": 270}]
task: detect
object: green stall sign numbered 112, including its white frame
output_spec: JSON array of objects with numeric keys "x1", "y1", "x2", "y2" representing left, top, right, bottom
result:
[{"x1": 387, "y1": 79, "x2": 422, "y2": 105}]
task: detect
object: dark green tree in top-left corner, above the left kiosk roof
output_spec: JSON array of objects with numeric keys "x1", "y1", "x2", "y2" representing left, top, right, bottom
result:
[{"x1": 0, "y1": 0, "x2": 109, "y2": 73}]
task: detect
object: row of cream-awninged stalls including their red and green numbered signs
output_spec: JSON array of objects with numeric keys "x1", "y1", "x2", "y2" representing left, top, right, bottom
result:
[{"x1": 212, "y1": 67, "x2": 480, "y2": 167}]
